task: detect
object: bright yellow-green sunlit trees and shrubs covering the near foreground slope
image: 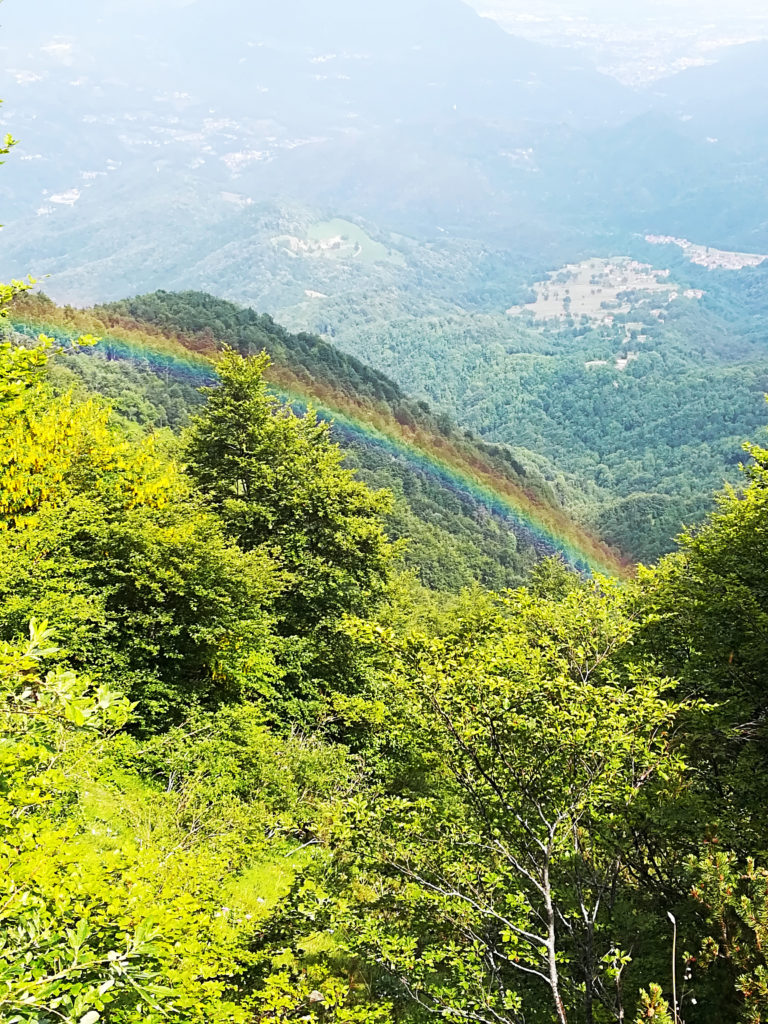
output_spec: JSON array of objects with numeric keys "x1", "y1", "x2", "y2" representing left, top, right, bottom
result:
[{"x1": 0, "y1": 287, "x2": 768, "y2": 1024}]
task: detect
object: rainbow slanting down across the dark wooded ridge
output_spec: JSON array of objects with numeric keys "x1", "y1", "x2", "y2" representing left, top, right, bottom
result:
[{"x1": 9, "y1": 302, "x2": 630, "y2": 577}]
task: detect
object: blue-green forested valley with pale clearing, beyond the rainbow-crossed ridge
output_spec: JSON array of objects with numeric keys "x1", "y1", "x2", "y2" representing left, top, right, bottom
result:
[{"x1": 309, "y1": 296, "x2": 768, "y2": 563}]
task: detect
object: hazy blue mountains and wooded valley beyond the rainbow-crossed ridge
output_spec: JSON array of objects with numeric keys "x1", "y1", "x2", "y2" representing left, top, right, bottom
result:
[{"x1": 0, "y1": 0, "x2": 768, "y2": 557}]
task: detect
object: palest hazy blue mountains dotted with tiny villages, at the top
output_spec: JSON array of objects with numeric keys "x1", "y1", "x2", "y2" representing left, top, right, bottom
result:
[{"x1": 0, "y1": 0, "x2": 768, "y2": 302}]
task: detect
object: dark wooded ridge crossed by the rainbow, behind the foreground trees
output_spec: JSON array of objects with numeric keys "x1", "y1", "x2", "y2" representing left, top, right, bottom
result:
[{"x1": 12, "y1": 292, "x2": 618, "y2": 592}]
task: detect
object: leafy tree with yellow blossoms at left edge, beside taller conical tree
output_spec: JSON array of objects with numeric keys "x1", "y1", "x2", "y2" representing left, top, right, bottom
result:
[{"x1": 0, "y1": 335, "x2": 285, "y2": 725}]
